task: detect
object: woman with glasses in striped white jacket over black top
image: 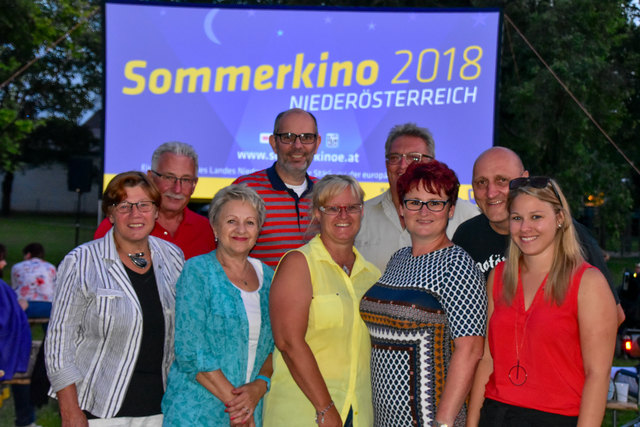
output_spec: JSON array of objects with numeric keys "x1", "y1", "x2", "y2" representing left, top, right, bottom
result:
[{"x1": 45, "y1": 172, "x2": 184, "y2": 426}]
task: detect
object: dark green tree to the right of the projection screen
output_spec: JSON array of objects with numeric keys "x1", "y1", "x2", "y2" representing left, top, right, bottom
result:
[{"x1": 482, "y1": 0, "x2": 638, "y2": 243}]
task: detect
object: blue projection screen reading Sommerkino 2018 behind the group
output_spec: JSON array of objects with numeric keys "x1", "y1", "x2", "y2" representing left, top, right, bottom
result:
[{"x1": 104, "y1": 2, "x2": 500, "y2": 199}]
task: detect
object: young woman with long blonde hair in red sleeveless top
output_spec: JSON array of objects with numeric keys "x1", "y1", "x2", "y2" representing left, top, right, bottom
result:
[{"x1": 468, "y1": 177, "x2": 617, "y2": 427}]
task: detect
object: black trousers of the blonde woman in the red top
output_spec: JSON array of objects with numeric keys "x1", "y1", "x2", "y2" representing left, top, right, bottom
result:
[{"x1": 479, "y1": 399, "x2": 578, "y2": 427}]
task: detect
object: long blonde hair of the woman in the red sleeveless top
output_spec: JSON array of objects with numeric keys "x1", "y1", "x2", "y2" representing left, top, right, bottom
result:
[{"x1": 502, "y1": 178, "x2": 584, "y2": 305}]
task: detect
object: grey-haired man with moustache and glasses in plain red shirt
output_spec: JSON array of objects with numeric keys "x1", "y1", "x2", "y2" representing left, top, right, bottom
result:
[{"x1": 93, "y1": 142, "x2": 216, "y2": 259}]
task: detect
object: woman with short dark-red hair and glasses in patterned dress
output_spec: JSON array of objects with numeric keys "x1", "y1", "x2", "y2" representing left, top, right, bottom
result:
[{"x1": 360, "y1": 160, "x2": 487, "y2": 427}]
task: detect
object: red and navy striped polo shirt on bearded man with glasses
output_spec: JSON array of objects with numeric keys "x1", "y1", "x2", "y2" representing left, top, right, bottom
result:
[{"x1": 233, "y1": 163, "x2": 316, "y2": 268}]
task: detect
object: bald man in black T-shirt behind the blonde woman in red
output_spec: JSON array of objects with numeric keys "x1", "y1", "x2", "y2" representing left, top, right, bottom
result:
[{"x1": 452, "y1": 147, "x2": 624, "y2": 323}]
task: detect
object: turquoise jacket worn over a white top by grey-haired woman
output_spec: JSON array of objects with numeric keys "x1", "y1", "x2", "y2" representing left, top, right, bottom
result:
[{"x1": 162, "y1": 251, "x2": 273, "y2": 427}]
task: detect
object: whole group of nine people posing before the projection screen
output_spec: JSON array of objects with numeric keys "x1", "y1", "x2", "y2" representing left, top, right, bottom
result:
[{"x1": 36, "y1": 109, "x2": 620, "y2": 427}]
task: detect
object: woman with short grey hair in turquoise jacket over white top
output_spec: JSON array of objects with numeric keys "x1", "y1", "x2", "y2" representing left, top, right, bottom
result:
[{"x1": 162, "y1": 185, "x2": 273, "y2": 427}]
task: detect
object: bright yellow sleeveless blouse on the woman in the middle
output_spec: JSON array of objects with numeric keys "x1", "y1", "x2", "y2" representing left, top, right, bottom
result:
[{"x1": 263, "y1": 235, "x2": 380, "y2": 427}]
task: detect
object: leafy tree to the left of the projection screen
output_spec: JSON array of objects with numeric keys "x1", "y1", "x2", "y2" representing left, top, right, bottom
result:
[{"x1": 0, "y1": 0, "x2": 102, "y2": 214}]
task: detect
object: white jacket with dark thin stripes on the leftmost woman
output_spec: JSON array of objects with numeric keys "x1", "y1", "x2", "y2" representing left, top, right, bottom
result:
[{"x1": 45, "y1": 229, "x2": 184, "y2": 418}]
